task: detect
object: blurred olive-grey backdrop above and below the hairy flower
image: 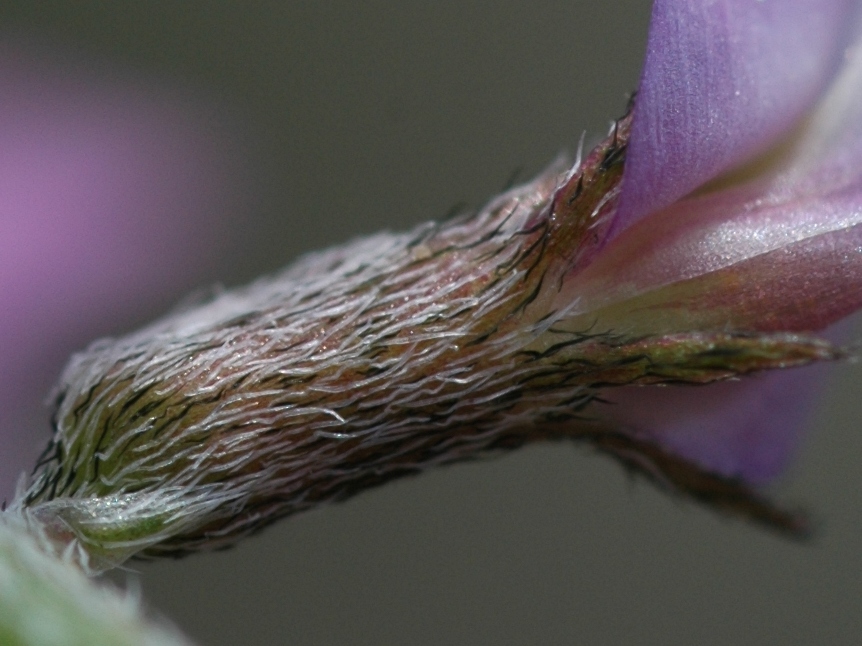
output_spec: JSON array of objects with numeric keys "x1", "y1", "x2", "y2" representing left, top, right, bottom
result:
[{"x1": 0, "y1": 0, "x2": 862, "y2": 646}]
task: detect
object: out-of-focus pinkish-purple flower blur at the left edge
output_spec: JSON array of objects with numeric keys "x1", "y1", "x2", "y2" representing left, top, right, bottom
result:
[{"x1": 0, "y1": 44, "x2": 246, "y2": 499}]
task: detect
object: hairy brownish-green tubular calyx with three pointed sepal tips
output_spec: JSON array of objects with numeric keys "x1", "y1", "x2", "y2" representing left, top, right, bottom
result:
[{"x1": 17, "y1": 109, "x2": 838, "y2": 570}]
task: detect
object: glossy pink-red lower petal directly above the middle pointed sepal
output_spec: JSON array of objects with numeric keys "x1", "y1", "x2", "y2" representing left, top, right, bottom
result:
[{"x1": 559, "y1": 186, "x2": 862, "y2": 335}]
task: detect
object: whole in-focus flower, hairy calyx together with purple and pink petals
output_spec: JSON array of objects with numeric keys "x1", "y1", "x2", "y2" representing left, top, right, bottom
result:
[{"x1": 13, "y1": 0, "x2": 862, "y2": 567}]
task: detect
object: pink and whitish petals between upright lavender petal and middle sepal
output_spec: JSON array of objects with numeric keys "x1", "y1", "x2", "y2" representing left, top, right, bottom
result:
[{"x1": 558, "y1": 8, "x2": 862, "y2": 340}]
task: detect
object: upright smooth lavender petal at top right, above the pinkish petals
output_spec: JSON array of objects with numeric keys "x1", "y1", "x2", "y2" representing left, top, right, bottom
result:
[{"x1": 610, "y1": 0, "x2": 856, "y2": 235}]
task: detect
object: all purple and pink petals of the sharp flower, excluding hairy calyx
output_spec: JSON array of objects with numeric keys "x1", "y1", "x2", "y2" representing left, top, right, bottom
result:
[{"x1": 572, "y1": 0, "x2": 862, "y2": 483}]
